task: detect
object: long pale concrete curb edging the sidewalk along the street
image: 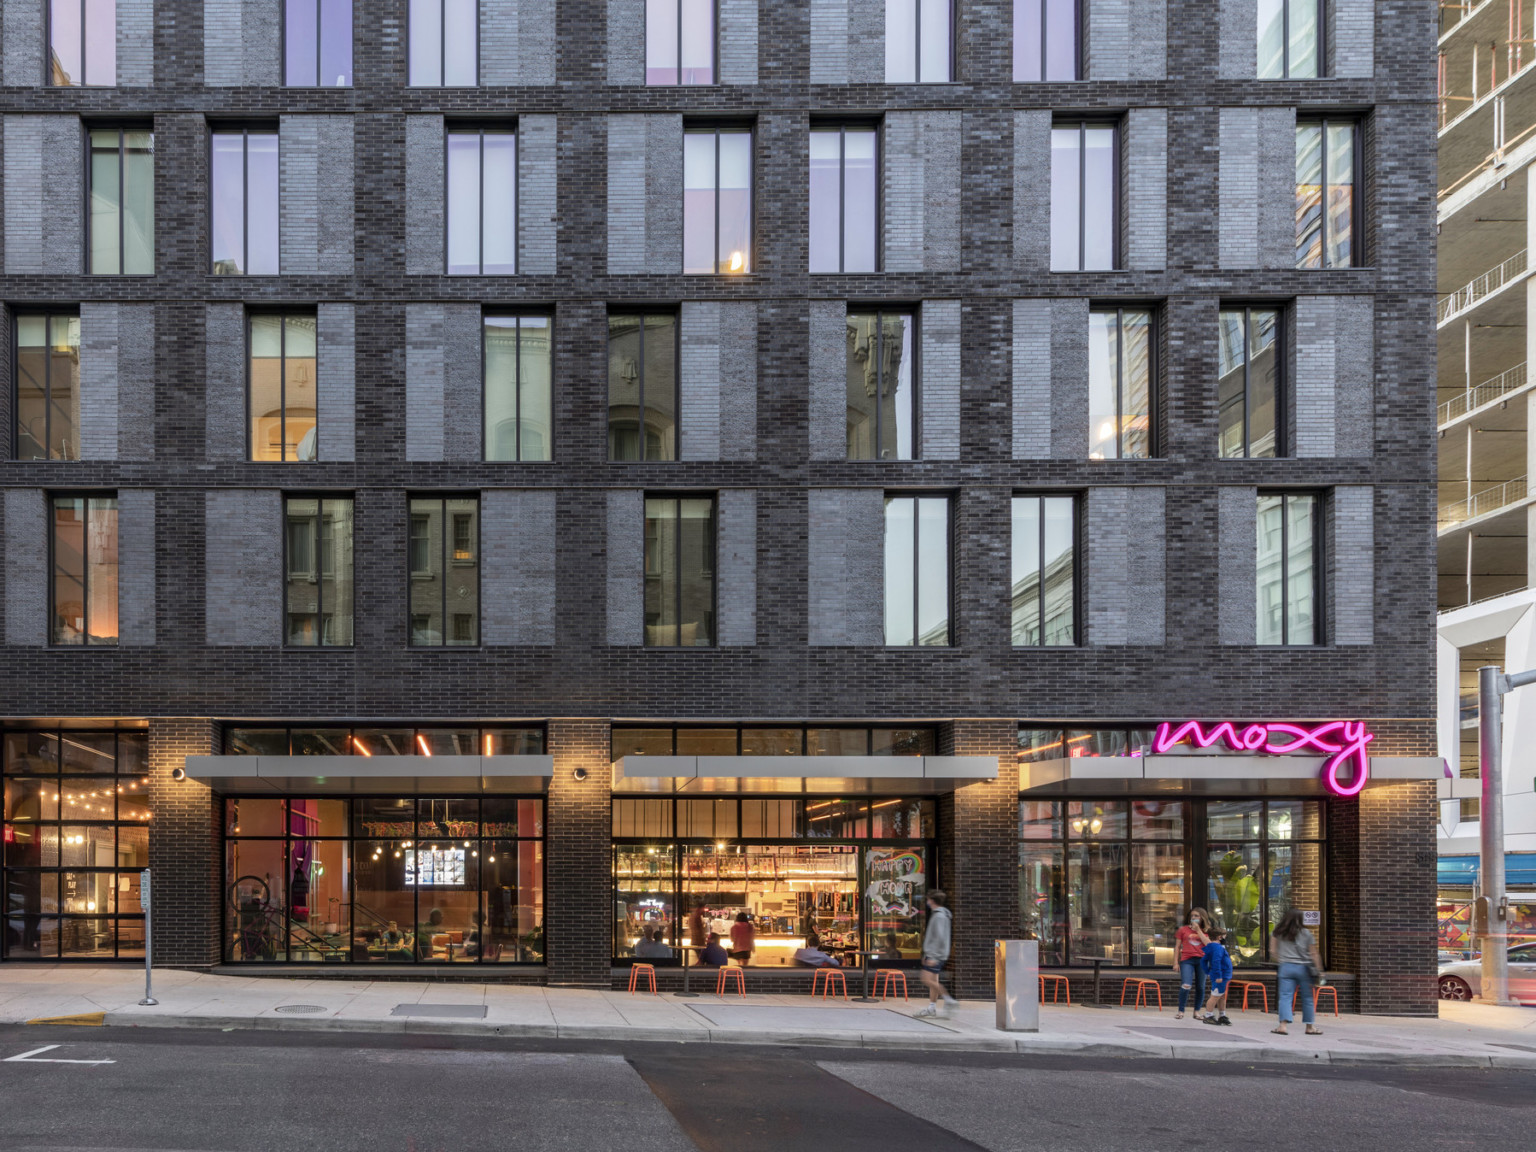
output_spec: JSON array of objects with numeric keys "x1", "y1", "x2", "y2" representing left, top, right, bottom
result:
[{"x1": 89, "y1": 1011, "x2": 1536, "y2": 1071}]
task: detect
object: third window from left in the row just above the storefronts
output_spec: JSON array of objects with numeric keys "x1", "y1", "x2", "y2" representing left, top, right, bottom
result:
[{"x1": 410, "y1": 496, "x2": 479, "y2": 648}]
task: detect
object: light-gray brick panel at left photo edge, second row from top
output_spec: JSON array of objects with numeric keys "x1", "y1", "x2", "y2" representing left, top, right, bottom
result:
[{"x1": 0, "y1": 115, "x2": 84, "y2": 276}]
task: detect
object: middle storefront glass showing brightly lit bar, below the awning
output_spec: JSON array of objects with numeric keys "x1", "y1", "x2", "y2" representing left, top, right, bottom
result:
[{"x1": 613, "y1": 797, "x2": 935, "y2": 966}]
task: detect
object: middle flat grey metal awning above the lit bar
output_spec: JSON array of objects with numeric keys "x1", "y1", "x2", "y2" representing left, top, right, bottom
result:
[{"x1": 613, "y1": 756, "x2": 997, "y2": 794}]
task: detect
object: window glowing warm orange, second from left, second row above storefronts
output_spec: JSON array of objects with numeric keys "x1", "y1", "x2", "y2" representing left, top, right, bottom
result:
[{"x1": 250, "y1": 315, "x2": 319, "y2": 462}]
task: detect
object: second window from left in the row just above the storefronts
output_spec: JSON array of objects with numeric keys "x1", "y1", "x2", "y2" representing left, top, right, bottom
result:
[{"x1": 283, "y1": 496, "x2": 352, "y2": 648}]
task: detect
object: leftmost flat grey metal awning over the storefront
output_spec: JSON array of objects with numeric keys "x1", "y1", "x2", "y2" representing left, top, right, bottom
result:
[{"x1": 186, "y1": 756, "x2": 554, "y2": 796}]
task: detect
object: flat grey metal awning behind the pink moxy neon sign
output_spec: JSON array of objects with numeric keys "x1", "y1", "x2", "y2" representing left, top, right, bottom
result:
[{"x1": 1018, "y1": 753, "x2": 1445, "y2": 796}]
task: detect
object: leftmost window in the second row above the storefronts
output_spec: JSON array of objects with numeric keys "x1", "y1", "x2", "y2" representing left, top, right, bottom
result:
[{"x1": 15, "y1": 312, "x2": 80, "y2": 459}]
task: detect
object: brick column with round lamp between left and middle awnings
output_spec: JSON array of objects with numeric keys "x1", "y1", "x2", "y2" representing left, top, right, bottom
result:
[{"x1": 544, "y1": 720, "x2": 613, "y2": 988}]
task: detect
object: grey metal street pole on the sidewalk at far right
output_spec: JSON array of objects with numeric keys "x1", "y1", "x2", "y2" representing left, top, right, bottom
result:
[{"x1": 1473, "y1": 664, "x2": 1536, "y2": 1005}]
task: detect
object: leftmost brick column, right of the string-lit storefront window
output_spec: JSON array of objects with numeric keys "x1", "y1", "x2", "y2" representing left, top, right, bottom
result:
[{"x1": 149, "y1": 719, "x2": 224, "y2": 968}]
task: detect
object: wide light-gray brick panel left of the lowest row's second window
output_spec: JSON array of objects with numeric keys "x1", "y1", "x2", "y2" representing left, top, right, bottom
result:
[{"x1": 203, "y1": 488, "x2": 284, "y2": 648}]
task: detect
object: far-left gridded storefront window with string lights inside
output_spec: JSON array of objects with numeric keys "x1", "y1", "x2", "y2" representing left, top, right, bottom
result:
[{"x1": 3, "y1": 730, "x2": 151, "y2": 960}]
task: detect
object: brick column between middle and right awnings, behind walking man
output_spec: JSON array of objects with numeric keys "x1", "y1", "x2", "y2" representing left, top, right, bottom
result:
[{"x1": 938, "y1": 720, "x2": 1020, "y2": 1000}]
